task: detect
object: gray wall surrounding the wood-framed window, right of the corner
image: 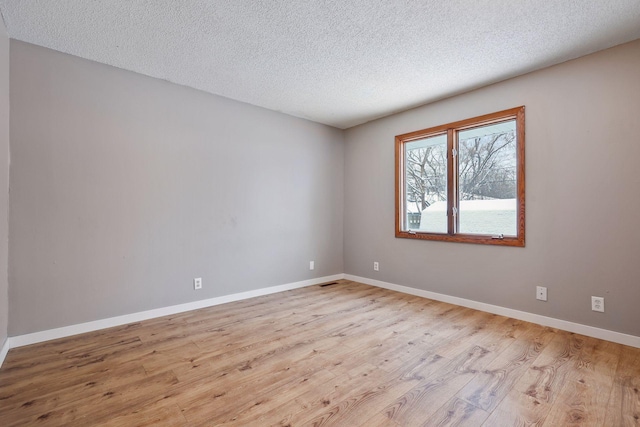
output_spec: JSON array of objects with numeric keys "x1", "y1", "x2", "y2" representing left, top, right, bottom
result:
[{"x1": 344, "y1": 41, "x2": 640, "y2": 335}]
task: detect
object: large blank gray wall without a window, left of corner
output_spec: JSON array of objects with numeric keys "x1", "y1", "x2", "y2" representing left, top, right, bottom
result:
[{"x1": 7, "y1": 40, "x2": 344, "y2": 336}]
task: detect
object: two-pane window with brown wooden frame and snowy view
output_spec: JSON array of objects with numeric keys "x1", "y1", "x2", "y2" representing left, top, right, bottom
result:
[{"x1": 396, "y1": 107, "x2": 525, "y2": 246}]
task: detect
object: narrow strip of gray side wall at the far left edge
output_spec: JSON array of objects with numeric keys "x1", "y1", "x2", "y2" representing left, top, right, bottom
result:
[{"x1": 0, "y1": 17, "x2": 9, "y2": 348}]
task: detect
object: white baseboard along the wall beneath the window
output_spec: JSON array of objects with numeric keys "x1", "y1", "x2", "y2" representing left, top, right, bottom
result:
[{"x1": 344, "y1": 274, "x2": 640, "y2": 348}]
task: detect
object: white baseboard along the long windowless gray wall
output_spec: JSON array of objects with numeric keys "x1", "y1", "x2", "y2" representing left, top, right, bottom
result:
[{"x1": 5, "y1": 274, "x2": 344, "y2": 354}]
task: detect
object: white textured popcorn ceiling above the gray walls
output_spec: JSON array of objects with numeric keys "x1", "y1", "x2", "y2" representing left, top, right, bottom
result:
[{"x1": 0, "y1": 0, "x2": 640, "y2": 128}]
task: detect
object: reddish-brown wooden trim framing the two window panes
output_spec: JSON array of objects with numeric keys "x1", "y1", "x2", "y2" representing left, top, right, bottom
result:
[{"x1": 395, "y1": 106, "x2": 525, "y2": 247}]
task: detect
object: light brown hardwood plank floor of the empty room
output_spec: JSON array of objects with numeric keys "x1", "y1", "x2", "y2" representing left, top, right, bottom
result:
[{"x1": 0, "y1": 280, "x2": 640, "y2": 427}]
